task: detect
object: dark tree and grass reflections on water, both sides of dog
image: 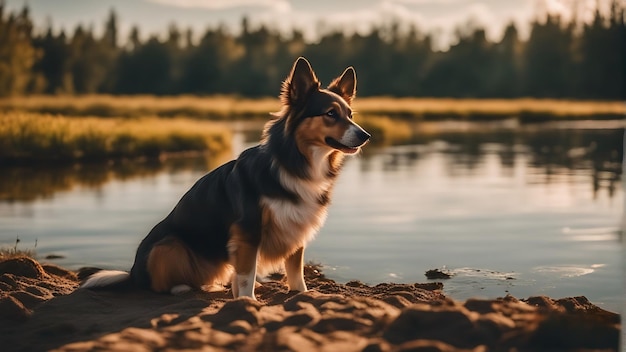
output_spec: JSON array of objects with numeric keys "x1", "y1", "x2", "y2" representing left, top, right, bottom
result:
[{"x1": 0, "y1": 121, "x2": 624, "y2": 202}]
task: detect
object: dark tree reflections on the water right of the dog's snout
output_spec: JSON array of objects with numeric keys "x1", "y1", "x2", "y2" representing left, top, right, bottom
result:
[{"x1": 362, "y1": 121, "x2": 624, "y2": 199}]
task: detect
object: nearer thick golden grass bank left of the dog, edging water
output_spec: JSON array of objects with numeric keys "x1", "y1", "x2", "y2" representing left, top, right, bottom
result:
[{"x1": 0, "y1": 112, "x2": 231, "y2": 161}]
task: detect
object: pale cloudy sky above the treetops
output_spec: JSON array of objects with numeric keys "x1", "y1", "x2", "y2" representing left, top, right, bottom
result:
[{"x1": 0, "y1": 0, "x2": 626, "y2": 49}]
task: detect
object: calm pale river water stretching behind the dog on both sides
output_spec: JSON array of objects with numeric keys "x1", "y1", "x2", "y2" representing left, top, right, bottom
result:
[{"x1": 0, "y1": 120, "x2": 625, "y2": 311}]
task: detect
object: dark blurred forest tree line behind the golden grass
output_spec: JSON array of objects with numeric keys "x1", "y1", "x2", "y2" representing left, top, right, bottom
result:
[{"x1": 0, "y1": 0, "x2": 626, "y2": 99}]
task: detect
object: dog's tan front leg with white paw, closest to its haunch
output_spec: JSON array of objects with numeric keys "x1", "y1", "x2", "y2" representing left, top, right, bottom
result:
[{"x1": 228, "y1": 226, "x2": 259, "y2": 300}]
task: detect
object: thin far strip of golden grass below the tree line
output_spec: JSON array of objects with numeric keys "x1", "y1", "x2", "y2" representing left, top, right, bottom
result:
[{"x1": 0, "y1": 95, "x2": 626, "y2": 121}]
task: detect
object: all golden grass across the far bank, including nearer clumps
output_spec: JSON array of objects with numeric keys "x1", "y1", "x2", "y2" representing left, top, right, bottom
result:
[{"x1": 0, "y1": 95, "x2": 626, "y2": 163}]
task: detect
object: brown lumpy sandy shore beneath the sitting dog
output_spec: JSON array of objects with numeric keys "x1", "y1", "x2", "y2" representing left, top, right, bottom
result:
[{"x1": 0, "y1": 258, "x2": 621, "y2": 352}]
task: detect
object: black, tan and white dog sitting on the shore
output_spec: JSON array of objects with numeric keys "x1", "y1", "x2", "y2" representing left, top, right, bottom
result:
[{"x1": 81, "y1": 57, "x2": 370, "y2": 299}]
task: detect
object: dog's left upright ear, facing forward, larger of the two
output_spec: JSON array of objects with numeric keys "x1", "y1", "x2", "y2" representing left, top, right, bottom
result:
[{"x1": 280, "y1": 57, "x2": 320, "y2": 106}]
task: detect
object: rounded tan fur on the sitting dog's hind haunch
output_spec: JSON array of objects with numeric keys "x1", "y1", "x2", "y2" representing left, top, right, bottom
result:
[{"x1": 147, "y1": 239, "x2": 228, "y2": 292}]
